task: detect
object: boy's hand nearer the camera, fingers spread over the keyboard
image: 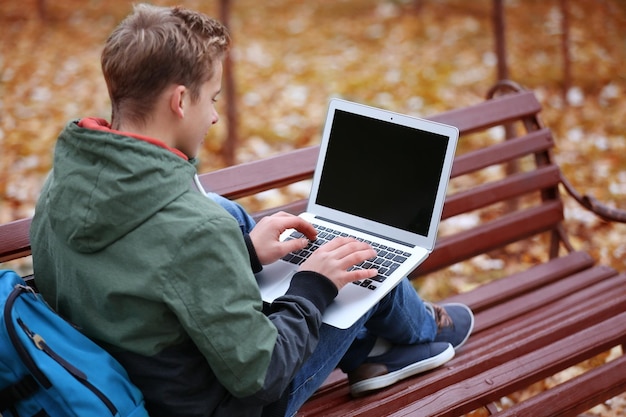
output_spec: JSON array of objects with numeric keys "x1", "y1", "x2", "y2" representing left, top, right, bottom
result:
[{"x1": 299, "y1": 237, "x2": 378, "y2": 290}]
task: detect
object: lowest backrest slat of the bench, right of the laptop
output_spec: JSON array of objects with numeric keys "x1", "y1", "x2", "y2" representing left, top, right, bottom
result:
[{"x1": 409, "y1": 200, "x2": 563, "y2": 278}]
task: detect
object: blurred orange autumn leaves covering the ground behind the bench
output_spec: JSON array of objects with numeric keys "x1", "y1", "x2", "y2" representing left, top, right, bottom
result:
[{"x1": 0, "y1": 0, "x2": 626, "y2": 417}]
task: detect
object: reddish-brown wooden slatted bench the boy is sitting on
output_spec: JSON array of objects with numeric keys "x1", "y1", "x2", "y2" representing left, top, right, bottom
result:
[{"x1": 0, "y1": 82, "x2": 626, "y2": 417}]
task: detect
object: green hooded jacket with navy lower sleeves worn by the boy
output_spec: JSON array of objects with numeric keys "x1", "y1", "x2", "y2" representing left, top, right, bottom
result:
[{"x1": 31, "y1": 119, "x2": 336, "y2": 415}]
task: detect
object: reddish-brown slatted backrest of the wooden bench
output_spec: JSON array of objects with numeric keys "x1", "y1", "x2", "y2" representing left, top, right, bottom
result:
[{"x1": 0, "y1": 90, "x2": 567, "y2": 274}]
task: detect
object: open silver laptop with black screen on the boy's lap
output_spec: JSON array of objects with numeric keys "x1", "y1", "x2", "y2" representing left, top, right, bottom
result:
[{"x1": 256, "y1": 99, "x2": 459, "y2": 329}]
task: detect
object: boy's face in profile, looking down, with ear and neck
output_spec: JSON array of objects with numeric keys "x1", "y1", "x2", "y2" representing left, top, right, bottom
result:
[{"x1": 174, "y1": 61, "x2": 222, "y2": 158}]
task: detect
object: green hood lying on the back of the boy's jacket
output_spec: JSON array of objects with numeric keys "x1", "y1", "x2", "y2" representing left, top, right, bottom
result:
[{"x1": 46, "y1": 119, "x2": 196, "y2": 253}]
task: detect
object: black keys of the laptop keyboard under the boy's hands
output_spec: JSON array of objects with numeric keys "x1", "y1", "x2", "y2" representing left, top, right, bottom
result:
[{"x1": 283, "y1": 224, "x2": 410, "y2": 290}]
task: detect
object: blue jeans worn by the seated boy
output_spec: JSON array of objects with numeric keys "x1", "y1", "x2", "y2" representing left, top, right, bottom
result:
[{"x1": 207, "y1": 193, "x2": 437, "y2": 416}]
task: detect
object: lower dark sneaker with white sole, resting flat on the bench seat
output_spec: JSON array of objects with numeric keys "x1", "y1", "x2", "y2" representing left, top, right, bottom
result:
[{"x1": 348, "y1": 342, "x2": 454, "y2": 397}]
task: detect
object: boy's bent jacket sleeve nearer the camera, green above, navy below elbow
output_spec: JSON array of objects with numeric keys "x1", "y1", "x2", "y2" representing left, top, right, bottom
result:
[{"x1": 164, "y1": 216, "x2": 336, "y2": 404}]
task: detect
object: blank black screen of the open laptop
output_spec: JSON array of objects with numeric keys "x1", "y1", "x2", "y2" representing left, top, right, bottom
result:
[{"x1": 316, "y1": 109, "x2": 449, "y2": 236}]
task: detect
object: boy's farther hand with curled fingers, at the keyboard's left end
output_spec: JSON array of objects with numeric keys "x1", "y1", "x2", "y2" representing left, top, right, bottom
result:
[{"x1": 250, "y1": 211, "x2": 317, "y2": 265}]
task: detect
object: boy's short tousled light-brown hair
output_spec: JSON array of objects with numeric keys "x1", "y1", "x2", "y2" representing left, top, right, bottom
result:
[{"x1": 101, "y1": 4, "x2": 230, "y2": 123}]
